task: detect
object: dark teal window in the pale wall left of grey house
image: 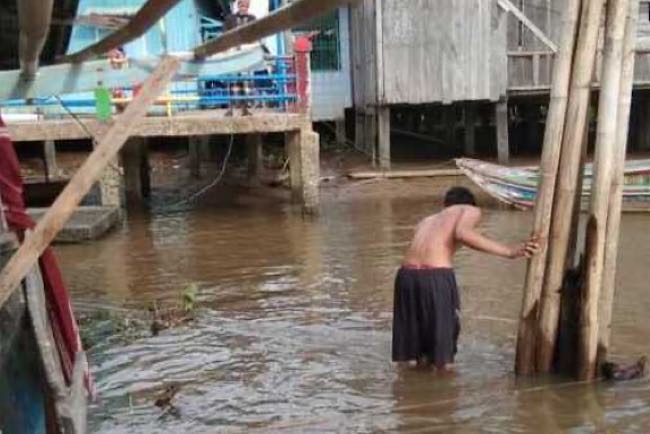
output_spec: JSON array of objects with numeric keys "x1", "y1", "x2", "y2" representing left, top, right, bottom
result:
[{"x1": 293, "y1": 11, "x2": 341, "y2": 71}]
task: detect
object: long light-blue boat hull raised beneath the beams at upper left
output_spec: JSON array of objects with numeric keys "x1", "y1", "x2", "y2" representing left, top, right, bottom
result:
[{"x1": 0, "y1": 44, "x2": 265, "y2": 101}]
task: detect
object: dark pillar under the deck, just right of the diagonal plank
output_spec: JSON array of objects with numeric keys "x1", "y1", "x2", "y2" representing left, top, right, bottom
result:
[{"x1": 121, "y1": 137, "x2": 151, "y2": 205}]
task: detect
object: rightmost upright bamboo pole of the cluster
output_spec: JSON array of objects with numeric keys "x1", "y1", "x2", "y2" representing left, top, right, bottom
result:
[{"x1": 598, "y1": 1, "x2": 639, "y2": 366}]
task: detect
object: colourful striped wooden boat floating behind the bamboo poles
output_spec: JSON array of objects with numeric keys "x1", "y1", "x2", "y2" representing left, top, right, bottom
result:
[{"x1": 456, "y1": 158, "x2": 650, "y2": 210}]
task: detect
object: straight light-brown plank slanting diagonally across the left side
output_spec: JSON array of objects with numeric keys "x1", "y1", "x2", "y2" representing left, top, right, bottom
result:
[{"x1": 0, "y1": 57, "x2": 180, "y2": 307}]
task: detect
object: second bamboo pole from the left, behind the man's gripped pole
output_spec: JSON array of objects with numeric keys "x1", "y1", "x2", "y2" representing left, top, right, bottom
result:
[{"x1": 536, "y1": 0, "x2": 604, "y2": 372}]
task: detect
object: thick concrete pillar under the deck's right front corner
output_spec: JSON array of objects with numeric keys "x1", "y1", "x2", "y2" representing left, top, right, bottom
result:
[{"x1": 285, "y1": 129, "x2": 320, "y2": 214}]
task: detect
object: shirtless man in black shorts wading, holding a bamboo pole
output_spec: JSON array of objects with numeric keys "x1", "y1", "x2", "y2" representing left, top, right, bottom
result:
[{"x1": 393, "y1": 187, "x2": 539, "y2": 370}]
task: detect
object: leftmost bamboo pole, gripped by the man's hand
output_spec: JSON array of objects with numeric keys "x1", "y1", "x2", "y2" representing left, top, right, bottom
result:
[{"x1": 515, "y1": 0, "x2": 582, "y2": 375}]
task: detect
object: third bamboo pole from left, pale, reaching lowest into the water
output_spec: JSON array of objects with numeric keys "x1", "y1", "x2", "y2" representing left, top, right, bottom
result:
[{"x1": 578, "y1": 0, "x2": 629, "y2": 380}]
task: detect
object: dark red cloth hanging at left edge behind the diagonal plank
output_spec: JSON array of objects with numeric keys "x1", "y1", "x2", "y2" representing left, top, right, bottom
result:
[{"x1": 0, "y1": 116, "x2": 94, "y2": 395}]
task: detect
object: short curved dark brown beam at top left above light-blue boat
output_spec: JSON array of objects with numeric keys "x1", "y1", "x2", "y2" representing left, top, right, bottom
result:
[{"x1": 60, "y1": 0, "x2": 180, "y2": 63}]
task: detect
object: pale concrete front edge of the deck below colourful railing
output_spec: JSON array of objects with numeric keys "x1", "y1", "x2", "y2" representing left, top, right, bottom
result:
[{"x1": 7, "y1": 110, "x2": 310, "y2": 142}]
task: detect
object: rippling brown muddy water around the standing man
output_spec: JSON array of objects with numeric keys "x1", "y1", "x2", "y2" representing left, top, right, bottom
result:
[{"x1": 52, "y1": 182, "x2": 650, "y2": 433}]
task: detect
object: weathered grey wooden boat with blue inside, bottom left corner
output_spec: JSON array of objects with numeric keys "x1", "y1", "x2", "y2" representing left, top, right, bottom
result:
[{"x1": 0, "y1": 229, "x2": 87, "y2": 434}]
